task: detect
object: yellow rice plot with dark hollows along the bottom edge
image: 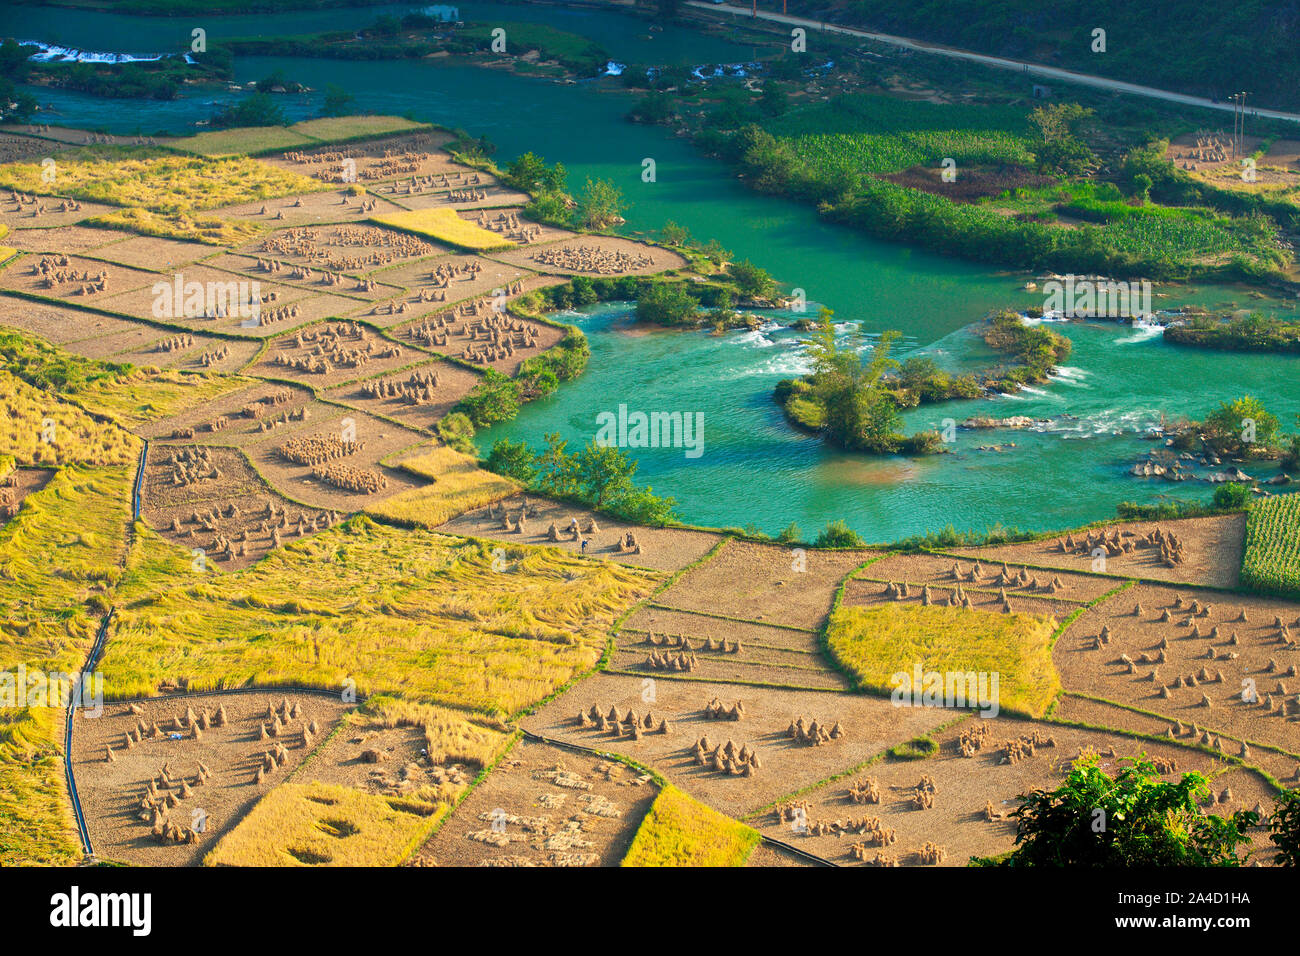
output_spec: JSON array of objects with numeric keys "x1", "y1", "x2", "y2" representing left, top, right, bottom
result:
[{"x1": 203, "y1": 782, "x2": 449, "y2": 866}]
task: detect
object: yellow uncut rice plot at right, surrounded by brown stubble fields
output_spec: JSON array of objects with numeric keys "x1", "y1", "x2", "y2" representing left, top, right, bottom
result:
[{"x1": 827, "y1": 604, "x2": 1061, "y2": 717}]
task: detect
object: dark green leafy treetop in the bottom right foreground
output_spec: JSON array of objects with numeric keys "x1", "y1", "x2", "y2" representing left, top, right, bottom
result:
[{"x1": 979, "y1": 754, "x2": 1258, "y2": 868}]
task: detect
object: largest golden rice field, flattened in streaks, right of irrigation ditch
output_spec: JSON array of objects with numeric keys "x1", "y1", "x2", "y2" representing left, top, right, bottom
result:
[{"x1": 103, "y1": 516, "x2": 659, "y2": 715}]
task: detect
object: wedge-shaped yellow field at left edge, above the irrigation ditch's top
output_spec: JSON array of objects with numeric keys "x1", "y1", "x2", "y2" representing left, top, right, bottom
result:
[{"x1": 0, "y1": 371, "x2": 140, "y2": 467}]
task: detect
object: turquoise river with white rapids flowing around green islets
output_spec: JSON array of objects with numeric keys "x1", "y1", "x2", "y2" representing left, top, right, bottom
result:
[{"x1": 0, "y1": 5, "x2": 1300, "y2": 540}]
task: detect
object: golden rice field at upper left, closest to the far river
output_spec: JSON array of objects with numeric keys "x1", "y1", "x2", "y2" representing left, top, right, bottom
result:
[{"x1": 0, "y1": 147, "x2": 322, "y2": 215}]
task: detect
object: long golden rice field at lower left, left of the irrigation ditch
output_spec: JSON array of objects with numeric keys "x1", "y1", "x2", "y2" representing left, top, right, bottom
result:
[{"x1": 0, "y1": 467, "x2": 135, "y2": 865}]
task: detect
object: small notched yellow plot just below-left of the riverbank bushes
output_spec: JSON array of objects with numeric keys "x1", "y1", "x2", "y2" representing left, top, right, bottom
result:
[{"x1": 365, "y1": 446, "x2": 520, "y2": 528}]
